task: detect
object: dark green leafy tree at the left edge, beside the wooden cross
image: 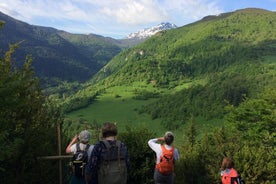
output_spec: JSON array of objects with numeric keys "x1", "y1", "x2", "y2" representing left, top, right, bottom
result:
[{"x1": 0, "y1": 39, "x2": 61, "y2": 183}]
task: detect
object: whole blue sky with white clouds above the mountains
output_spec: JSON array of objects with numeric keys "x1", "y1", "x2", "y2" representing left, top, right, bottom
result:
[{"x1": 0, "y1": 0, "x2": 276, "y2": 38}]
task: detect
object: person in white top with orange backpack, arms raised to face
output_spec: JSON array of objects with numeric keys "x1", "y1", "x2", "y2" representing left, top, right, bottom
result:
[{"x1": 148, "y1": 132, "x2": 179, "y2": 184}]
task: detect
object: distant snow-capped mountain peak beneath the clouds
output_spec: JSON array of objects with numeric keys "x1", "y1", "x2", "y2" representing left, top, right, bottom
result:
[{"x1": 126, "y1": 22, "x2": 177, "y2": 39}]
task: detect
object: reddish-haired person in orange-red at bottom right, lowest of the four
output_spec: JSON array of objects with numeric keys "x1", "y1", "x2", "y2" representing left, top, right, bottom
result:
[{"x1": 221, "y1": 157, "x2": 238, "y2": 184}]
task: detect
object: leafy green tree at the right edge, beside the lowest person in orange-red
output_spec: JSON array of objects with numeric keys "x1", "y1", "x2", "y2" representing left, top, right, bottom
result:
[{"x1": 222, "y1": 88, "x2": 276, "y2": 183}]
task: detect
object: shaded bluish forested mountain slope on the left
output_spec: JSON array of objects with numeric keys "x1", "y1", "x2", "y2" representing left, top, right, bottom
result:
[{"x1": 0, "y1": 12, "x2": 121, "y2": 85}]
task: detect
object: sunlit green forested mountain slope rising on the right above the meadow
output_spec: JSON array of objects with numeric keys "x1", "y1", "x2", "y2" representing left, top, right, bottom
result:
[{"x1": 65, "y1": 9, "x2": 276, "y2": 120}]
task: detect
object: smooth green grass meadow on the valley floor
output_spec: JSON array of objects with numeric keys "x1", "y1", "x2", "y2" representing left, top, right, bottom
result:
[{"x1": 65, "y1": 81, "x2": 222, "y2": 144}]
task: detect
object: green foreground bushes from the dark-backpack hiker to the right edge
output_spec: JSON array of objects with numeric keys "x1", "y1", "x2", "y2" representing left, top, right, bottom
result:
[{"x1": 62, "y1": 89, "x2": 276, "y2": 184}]
